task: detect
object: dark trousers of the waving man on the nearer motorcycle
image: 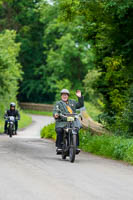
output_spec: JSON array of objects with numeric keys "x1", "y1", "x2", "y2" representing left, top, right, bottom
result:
[{"x1": 55, "y1": 128, "x2": 79, "y2": 148}]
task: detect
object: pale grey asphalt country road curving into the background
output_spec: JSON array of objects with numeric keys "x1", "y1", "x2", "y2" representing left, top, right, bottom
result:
[{"x1": 0, "y1": 116, "x2": 133, "y2": 200}]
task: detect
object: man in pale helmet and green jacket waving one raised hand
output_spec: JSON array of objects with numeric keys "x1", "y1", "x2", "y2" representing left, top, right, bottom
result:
[{"x1": 53, "y1": 89, "x2": 84, "y2": 152}]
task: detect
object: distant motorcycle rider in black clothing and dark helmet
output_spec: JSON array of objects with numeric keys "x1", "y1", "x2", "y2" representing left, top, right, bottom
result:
[{"x1": 4, "y1": 102, "x2": 20, "y2": 134}]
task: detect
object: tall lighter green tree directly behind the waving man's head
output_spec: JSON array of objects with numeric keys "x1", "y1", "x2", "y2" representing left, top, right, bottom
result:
[{"x1": 38, "y1": 3, "x2": 94, "y2": 101}]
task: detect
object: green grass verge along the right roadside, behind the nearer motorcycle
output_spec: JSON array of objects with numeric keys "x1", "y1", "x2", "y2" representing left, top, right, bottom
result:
[{"x1": 41, "y1": 123, "x2": 133, "y2": 164}]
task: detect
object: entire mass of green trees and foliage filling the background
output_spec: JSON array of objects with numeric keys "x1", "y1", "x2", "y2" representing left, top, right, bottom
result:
[{"x1": 0, "y1": 0, "x2": 133, "y2": 136}]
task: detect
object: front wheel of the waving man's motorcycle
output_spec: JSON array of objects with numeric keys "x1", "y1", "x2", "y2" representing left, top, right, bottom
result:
[{"x1": 69, "y1": 135, "x2": 77, "y2": 163}]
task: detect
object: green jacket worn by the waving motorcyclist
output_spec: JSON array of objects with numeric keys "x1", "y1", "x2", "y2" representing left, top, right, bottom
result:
[{"x1": 53, "y1": 96, "x2": 84, "y2": 128}]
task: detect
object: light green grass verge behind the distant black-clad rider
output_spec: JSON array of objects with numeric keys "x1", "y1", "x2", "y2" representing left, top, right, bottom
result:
[{"x1": 0, "y1": 111, "x2": 32, "y2": 133}]
